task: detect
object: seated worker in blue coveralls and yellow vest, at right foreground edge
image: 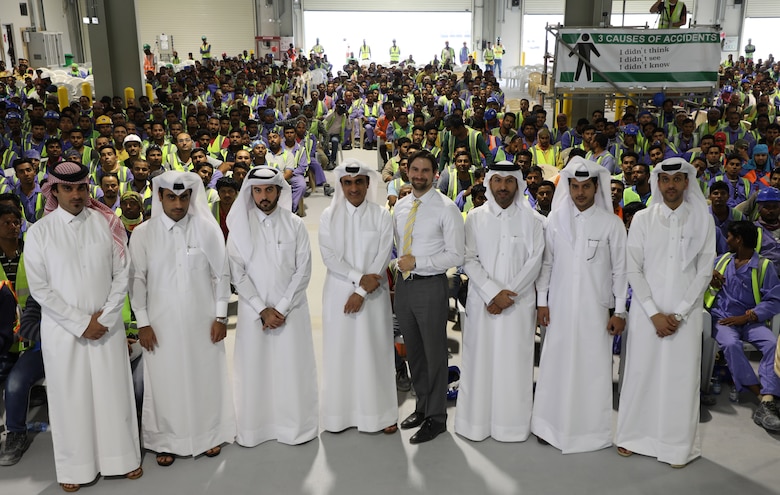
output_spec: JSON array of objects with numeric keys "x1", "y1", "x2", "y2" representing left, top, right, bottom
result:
[{"x1": 704, "y1": 221, "x2": 780, "y2": 432}]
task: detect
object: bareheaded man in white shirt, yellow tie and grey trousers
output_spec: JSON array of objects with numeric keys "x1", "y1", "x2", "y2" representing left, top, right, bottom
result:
[{"x1": 393, "y1": 150, "x2": 465, "y2": 444}]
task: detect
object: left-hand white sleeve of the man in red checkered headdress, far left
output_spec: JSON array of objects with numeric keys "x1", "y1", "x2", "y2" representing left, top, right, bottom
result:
[{"x1": 24, "y1": 228, "x2": 92, "y2": 337}]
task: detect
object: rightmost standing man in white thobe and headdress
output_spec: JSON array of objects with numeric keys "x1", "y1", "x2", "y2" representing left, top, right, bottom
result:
[{"x1": 615, "y1": 158, "x2": 715, "y2": 467}]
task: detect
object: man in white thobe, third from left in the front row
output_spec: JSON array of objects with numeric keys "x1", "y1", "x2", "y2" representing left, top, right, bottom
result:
[{"x1": 227, "y1": 166, "x2": 319, "y2": 447}]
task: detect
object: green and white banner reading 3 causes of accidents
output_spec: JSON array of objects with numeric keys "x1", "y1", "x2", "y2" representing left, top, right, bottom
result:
[{"x1": 555, "y1": 28, "x2": 720, "y2": 92}]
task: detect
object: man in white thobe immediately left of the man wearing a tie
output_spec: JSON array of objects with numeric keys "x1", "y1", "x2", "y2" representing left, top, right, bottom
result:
[{"x1": 319, "y1": 159, "x2": 398, "y2": 434}]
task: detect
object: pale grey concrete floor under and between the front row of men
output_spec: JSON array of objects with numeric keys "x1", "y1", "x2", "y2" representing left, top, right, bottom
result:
[{"x1": 0, "y1": 146, "x2": 780, "y2": 495}]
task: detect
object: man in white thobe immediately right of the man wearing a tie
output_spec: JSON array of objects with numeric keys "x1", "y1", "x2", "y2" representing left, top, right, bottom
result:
[{"x1": 455, "y1": 162, "x2": 544, "y2": 442}]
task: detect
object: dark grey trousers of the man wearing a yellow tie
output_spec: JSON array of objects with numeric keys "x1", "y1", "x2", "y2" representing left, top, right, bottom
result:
[{"x1": 395, "y1": 273, "x2": 448, "y2": 423}]
